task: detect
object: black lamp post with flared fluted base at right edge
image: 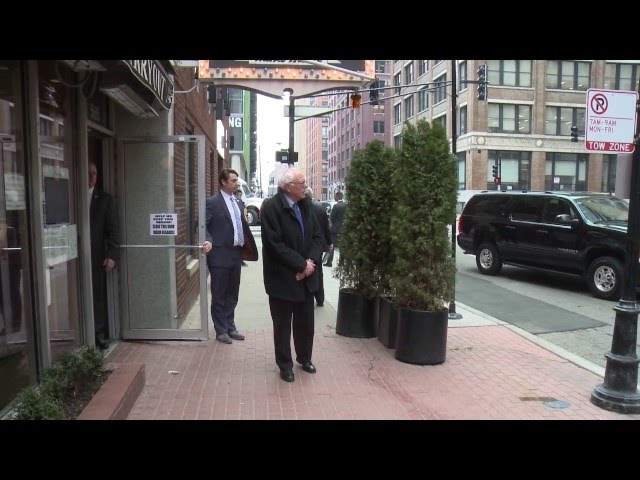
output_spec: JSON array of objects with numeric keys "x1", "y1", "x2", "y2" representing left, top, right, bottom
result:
[{"x1": 587, "y1": 91, "x2": 640, "y2": 413}]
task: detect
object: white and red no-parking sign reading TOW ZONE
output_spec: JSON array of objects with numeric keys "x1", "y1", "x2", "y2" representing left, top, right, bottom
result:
[{"x1": 585, "y1": 88, "x2": 638, "y2": 153}]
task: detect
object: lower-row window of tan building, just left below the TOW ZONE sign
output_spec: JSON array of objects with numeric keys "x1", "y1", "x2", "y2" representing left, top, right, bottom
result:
[{"x1": 544, "y1": 152, "x2": 588, "y2": 191}]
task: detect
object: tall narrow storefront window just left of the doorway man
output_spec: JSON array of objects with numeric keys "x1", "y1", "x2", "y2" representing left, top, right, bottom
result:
[{"x1": 38, "y1": 62, "x2": 81, "y2": 362}]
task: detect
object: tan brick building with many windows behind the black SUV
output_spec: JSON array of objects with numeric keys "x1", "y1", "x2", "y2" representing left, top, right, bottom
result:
[{"x1": 388, "y1": 60, "x2": 640, "y2": 192}]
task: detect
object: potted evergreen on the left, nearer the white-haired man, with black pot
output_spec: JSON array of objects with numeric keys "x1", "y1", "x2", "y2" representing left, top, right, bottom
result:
[{"x1": 335, "y1": 140, "x2": 393, "y2": 338}]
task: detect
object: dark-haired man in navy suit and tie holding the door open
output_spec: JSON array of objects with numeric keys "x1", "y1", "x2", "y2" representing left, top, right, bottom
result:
[{"x1": 202, "y1": 168, "x2": 258, "y2": 343}]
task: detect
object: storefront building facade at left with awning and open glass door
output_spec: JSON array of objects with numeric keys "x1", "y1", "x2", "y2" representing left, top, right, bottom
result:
[{"x1": 0, "y1": 60, "x2": 229, "y2": 415}]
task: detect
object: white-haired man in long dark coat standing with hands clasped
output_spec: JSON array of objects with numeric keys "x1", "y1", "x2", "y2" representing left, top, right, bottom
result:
[{"x1": 260, "y1": 168, "x2": 324, "y2": 382}]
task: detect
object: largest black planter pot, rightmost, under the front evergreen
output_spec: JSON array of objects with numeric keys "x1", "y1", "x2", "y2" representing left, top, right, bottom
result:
[{"x1": 396, "y1": 307, "x2": 449, "y2": 365}]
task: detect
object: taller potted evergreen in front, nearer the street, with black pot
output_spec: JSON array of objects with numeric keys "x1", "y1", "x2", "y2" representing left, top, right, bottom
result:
[{"x1": 390, "y1": 119, "x2": 457, "y2": 365}]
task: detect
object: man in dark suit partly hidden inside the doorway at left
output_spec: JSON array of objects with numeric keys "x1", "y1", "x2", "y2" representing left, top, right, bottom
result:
[{"x1": 89, "y1": 162, "x2": 120, "y2": 350}]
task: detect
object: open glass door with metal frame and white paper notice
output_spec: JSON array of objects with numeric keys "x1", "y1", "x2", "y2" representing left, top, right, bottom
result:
[{"x1": 118, "y1": 135, "x2": 209, "y2": 340}]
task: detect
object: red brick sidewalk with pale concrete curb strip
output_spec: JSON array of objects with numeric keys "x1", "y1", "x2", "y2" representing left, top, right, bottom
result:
[{"x1": 107, "y1": 231, "x2": 640, "y2": 420}]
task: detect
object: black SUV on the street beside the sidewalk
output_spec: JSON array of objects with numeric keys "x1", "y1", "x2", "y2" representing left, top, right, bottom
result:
[{"x1": 457, "y1": 191, "x2": 640, "y2": 300}]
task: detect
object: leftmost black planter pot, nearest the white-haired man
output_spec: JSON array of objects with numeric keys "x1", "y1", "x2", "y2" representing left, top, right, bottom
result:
[{"x1": 336, "y1": 288, "x2": 376, "y2": 338}]
